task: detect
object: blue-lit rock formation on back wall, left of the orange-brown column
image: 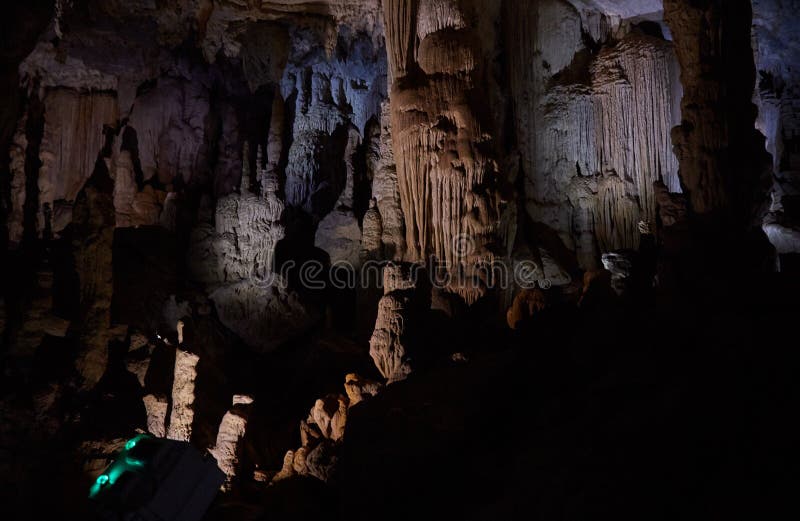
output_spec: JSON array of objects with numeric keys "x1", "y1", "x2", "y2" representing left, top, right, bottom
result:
[{"x1": 280, "y1": 31, "x2": 386, "y2": 218}]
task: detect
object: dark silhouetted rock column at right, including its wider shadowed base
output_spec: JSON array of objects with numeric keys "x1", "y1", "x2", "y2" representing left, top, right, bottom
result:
[{"x1": 660, "y1": 0, "x2": 772, "y2": 286}]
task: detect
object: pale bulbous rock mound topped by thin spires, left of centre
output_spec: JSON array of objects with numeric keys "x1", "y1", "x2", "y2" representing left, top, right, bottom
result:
[{"x1": 189, "y1": 147, "x2": 309, "y2": 350}]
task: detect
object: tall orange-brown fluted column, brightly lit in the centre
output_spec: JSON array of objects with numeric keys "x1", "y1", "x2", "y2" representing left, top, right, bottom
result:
[{"x1": 384, "y1": 0, "x2": 498, "y2": 302}]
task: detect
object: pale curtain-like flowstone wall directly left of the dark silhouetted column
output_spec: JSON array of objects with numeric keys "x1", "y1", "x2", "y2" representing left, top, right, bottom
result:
[{"x1": 506, "y1": 0, "x2": 681, "y2": 267}]
